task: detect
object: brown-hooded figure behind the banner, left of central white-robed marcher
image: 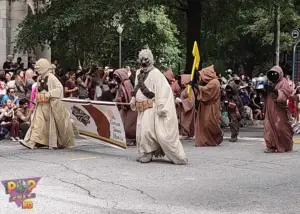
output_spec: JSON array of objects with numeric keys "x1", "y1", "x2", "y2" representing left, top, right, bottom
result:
[{"x1": 114, "y1": 69, "x2": 137, "y2": 146}]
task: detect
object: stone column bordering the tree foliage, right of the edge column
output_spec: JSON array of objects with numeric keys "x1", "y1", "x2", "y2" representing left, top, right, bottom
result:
[{"x1": 10, "y1": 1, "x2": 28, "y2": 67}]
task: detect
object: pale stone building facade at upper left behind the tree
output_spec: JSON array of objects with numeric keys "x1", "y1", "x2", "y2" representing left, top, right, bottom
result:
[{"x1": 0, "y1": 0, "x2": 51, "y2": 69}]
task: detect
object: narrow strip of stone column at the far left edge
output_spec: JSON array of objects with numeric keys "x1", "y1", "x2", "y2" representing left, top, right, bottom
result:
[{"x1": 0, "y1": 0, "x2": 12, "y2": 67}]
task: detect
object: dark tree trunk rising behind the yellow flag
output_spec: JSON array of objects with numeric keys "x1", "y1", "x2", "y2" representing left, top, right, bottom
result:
[{"x1": 185, "y1": 0, "x2": 201, "y2": 74}]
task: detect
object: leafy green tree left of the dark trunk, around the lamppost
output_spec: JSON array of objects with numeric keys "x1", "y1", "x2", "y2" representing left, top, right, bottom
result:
[{"x1": 16, "y1": 0, "x2": 181, "y2": 72}]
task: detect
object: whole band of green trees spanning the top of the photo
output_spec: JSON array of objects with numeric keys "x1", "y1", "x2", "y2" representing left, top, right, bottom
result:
[{"x1": 12, "y1": 0, "x2": 300, "y2": 74}]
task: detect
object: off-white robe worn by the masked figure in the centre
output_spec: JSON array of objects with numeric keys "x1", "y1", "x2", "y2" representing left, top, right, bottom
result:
[{"x1": 135, "y1": 68, "x2": 186, "y2": 164}]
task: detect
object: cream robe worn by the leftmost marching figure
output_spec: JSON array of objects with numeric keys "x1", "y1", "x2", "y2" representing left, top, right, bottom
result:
[{"x1": 24, "y1": 73, "x2": 75, "y2": 148}]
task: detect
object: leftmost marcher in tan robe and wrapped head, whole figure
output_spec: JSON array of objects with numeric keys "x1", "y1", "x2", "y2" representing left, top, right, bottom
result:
[{"x1": 20, "y1": 59, "x2": 75, "y2": 149}]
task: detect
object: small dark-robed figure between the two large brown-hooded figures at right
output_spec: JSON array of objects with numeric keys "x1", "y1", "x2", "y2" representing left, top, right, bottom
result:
[{"x1": 224, "y1": 82, "x2": 244, "y2": 142}]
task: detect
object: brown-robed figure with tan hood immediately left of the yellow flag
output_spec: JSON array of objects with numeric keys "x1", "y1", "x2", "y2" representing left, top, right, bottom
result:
[{"x1": 175, "y1": 74, "x2": 195, "y2": 140}]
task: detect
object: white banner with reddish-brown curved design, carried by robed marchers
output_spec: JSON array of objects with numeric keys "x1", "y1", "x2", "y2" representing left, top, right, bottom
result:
[{"x1": 62, "y1": 99, "x2": 127, "y2": 149}]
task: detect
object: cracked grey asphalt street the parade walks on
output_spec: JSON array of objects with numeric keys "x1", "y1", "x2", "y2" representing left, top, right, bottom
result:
[{"x1": 0, "y1": 128, "x2": 300, "y2": 214}]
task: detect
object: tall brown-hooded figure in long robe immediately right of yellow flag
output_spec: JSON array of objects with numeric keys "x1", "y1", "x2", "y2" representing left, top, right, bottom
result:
[{"x1": 195, "y1": 65, "x2": 223, "y2": 147}]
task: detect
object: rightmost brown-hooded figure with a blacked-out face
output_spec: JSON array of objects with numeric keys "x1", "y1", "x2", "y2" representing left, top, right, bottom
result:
[{"x1": 264, "y1": 66, "x2": 294, "y2": 153}]
